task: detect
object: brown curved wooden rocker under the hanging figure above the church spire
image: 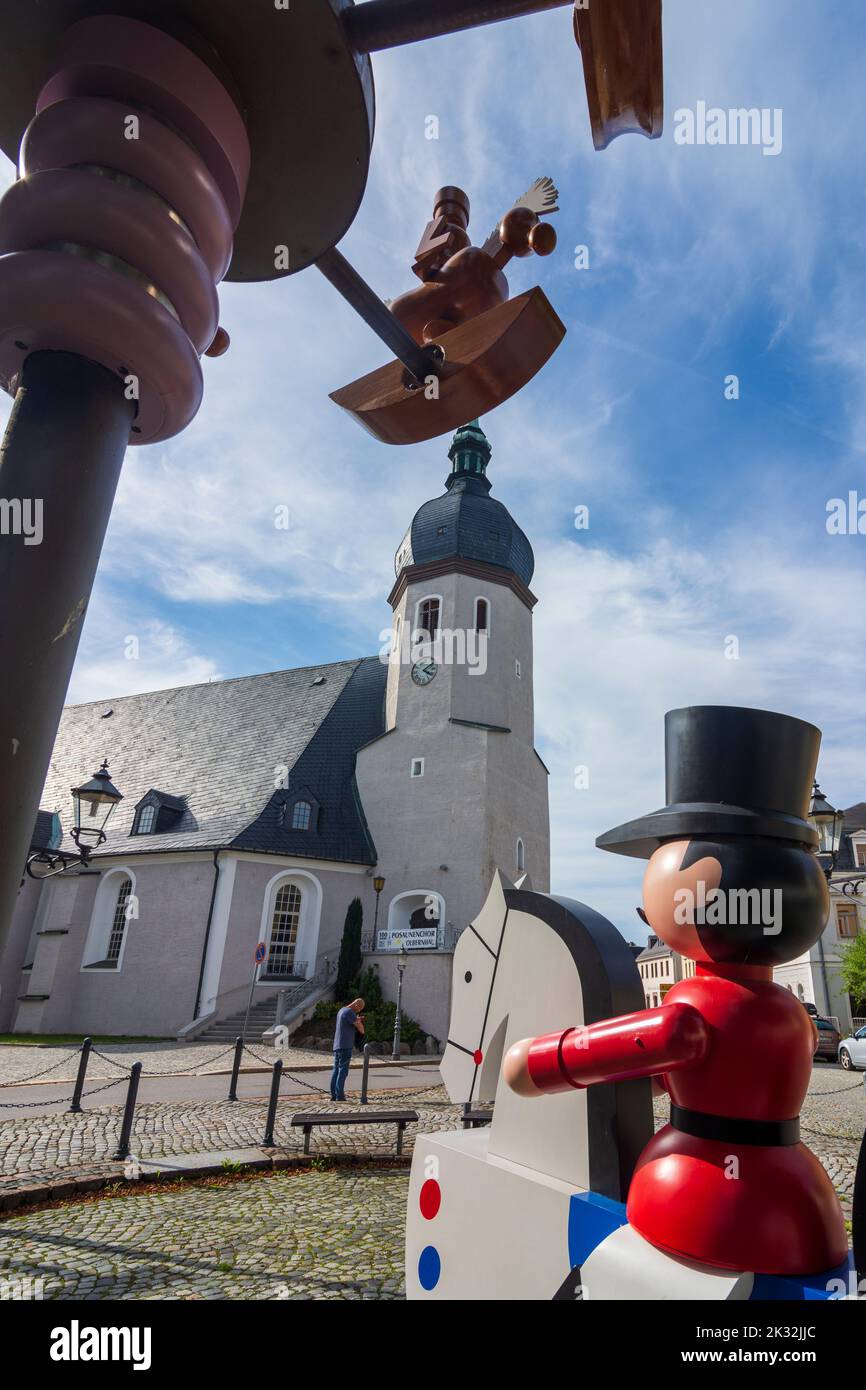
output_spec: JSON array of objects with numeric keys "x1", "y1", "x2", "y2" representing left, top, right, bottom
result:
[{"x1": 331, "y1": 289, "x2": 566, "y2": 443}]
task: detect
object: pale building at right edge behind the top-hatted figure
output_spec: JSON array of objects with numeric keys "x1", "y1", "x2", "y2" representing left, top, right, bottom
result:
[{"x1": 773, "y1": 802, "x2": 866, "y2": 1037}]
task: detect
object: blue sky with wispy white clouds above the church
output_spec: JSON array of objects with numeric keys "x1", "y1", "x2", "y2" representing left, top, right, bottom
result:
[{"x1": 0, "y1": 0, "x2": 866, "y2": 940}]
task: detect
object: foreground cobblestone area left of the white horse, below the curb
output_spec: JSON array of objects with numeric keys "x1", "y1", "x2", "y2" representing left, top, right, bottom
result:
[{"x1": 0, "y1": 1169, "x2": 409, "y2": 1301}]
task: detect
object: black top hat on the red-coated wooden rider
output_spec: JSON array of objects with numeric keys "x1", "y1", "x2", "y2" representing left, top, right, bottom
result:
[{"x1": 595, "y1": 705, "x2": 822, "y2": 859}]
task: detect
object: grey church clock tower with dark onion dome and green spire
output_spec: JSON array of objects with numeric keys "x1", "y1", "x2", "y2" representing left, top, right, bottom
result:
[{"x1": 357, "y1": 420, "x2": 550, "y2": 1037}]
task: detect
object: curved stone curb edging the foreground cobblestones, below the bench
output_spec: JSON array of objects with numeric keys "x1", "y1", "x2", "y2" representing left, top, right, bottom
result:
[{"x1": 0, "y1": 1148, "x2": 411, "y2": 1212}]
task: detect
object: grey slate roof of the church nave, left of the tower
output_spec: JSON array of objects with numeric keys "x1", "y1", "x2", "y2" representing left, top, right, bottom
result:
[{"x1": 40, "y1": 657, "x2": 388, "y2": 863}]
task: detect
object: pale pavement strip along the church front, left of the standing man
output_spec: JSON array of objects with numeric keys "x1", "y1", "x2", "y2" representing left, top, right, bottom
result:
[{"x1": 0, "y1": 1043, "x2": 329, "y2": 1086}]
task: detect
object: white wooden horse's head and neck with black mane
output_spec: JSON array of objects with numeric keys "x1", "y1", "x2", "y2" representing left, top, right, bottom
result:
[{"x1": 441, "y1": 874, "x2": 652, "y2": 1201}]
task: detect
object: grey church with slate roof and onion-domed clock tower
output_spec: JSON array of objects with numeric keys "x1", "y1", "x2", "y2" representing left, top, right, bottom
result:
[{"x1": 0, "y1": 423, "x2": 549, "y2": 1038}]
